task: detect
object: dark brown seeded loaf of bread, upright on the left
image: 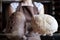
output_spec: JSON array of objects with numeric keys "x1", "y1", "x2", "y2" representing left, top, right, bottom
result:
[{"x1": 5, "y1": 11, "x2": 25, "y2": 37}]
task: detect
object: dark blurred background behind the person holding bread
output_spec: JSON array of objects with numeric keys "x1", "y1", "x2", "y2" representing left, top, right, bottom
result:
[{"x1": 0, "y1": 0, "x2": 60, "y2": 40}]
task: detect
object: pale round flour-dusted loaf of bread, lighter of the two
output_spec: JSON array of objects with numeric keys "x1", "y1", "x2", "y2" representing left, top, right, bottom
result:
[{"x1": 31, "y1": 14, "x2": 58, "y2": 35}]
